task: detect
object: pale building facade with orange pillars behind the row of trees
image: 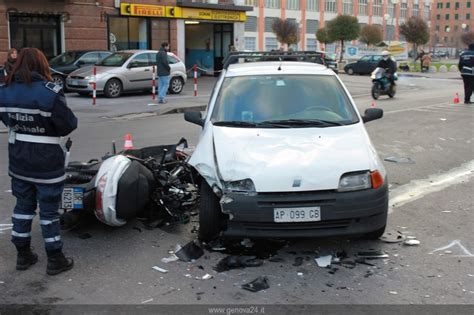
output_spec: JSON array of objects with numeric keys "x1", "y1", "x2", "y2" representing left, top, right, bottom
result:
[{"x1": 245, "y1": 0, "x2": 432, "y2": 50}]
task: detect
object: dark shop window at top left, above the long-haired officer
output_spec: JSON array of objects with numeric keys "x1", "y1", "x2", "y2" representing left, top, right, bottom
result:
[{"x1": 8, "y1": 14, "x2": 61, "y2": 58}]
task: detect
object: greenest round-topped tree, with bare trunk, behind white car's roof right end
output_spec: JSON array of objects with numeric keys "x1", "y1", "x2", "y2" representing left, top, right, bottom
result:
[{"x1": 326, "y1": 15, "x2": 360, "y2": 62}]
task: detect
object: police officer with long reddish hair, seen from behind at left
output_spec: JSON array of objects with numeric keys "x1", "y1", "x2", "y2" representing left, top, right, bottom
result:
[{"x1": 0, "y1": 48, "x2": 77, "y2": 275}]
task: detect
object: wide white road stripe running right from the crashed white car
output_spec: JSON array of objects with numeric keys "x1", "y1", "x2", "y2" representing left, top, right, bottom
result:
[{"x1": 388, "y1": 160, "x2": 474, "y2": 213}]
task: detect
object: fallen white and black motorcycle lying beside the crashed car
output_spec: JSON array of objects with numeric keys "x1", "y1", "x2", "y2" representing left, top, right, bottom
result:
[{"x1": 60, "y1": 138, "x2": 199, "y2": 229}]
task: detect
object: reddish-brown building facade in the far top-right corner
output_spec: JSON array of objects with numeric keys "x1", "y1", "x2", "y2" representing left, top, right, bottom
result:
[{"x1": 430, "y1": 0, "x2": 474, "y2": 55}]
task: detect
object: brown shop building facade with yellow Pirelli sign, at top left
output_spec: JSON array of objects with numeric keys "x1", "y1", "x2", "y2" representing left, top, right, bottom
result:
[{"x1": 0, "y1": 0, "x2": 253, "y2": 71}]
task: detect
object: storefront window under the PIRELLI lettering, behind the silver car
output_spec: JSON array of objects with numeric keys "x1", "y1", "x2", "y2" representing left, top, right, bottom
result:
[{"x1": 109, "y1": 17, "x2": 151, "y2": 51}]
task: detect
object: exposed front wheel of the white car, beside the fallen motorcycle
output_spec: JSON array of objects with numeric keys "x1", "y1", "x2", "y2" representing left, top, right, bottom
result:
[{"x1": 199, "y1": 180, "x2": 224, "y2": 241}]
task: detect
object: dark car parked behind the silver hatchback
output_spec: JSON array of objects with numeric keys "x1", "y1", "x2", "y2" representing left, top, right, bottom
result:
[{"x1": 49, "y1": 50, "x2": 112, "y2": 86}]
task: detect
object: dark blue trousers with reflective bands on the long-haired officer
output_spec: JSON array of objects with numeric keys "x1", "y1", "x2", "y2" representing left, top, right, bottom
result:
[{"x1": 12, "y1": 177, "x2": 64, "y2": 251}]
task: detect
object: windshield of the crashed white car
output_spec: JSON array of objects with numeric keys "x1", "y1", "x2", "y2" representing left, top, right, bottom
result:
[{"x1": 211, "y1": 75, "x2": 358, "y2": 128}]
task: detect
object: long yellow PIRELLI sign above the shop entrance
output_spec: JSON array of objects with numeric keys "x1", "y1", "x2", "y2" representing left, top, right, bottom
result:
[{"x1": 120, "y1": 3, "x2": 247, "y2": 22}]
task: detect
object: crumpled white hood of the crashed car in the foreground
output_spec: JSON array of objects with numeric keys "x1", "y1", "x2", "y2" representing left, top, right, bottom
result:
[{"x1": 190, "y1": 123, "x2": 376, "y2": 192}]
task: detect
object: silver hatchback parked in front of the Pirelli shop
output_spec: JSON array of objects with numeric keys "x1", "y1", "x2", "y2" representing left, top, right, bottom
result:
[{"x1": 66, "y1": 50, "x2": 187, "y2": 97}]
